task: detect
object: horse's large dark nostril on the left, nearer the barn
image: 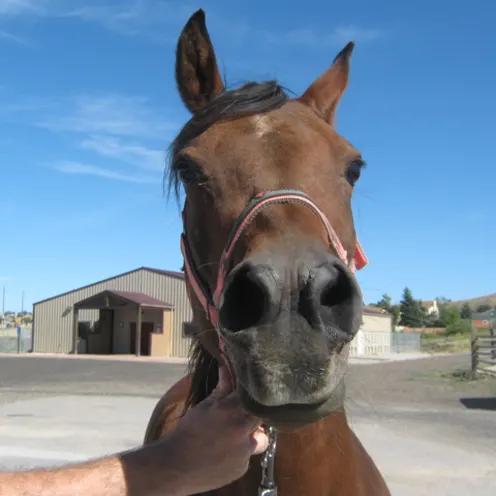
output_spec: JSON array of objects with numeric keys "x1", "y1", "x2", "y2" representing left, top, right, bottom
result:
[{"x1": 219, "y1": 263, "x2": 277, "y2": 332}]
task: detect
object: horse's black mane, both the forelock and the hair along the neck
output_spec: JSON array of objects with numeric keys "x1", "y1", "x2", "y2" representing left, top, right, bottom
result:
[{"x1": 164, "y1": 80, "x2": 288, "y2": 411}]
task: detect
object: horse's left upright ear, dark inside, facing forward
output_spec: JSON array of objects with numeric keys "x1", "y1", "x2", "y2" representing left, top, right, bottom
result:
[{"x1": 176, "y1": 9, "x2": 224, "y2": 113}]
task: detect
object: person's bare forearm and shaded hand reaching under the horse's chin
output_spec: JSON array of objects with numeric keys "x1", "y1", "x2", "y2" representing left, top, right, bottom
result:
[{"x1": 0, "y1": 368, "x2": 267, "y2": 496}]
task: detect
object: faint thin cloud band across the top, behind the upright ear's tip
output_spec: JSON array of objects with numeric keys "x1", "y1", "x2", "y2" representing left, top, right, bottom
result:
[{"x1": 0, "y1": 0, "x2": 384, "y2": 49}]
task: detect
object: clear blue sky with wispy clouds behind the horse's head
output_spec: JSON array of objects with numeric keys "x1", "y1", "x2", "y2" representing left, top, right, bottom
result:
[{"x1": 0, "y1": 0, "x2": 496, "y2": 310}]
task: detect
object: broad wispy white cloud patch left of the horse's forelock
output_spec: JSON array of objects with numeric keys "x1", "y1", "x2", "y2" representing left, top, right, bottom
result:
[{"x1": 0, "y1": 90, "x2": 173, "y2": 184}]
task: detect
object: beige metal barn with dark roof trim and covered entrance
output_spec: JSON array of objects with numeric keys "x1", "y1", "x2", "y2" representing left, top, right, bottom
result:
[{"x1": 33, "y1": 267, "x2": 192, "y2": 357}]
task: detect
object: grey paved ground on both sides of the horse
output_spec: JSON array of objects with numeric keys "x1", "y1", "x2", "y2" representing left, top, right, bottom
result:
[{"x1": 0, "y1": 356, "x2": 496, "y2": 496}]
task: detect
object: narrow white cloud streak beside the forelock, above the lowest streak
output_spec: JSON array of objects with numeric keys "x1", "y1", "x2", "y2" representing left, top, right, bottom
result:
[{"x1": 81, "y1": 136, "x2": 165, "y2": 172}]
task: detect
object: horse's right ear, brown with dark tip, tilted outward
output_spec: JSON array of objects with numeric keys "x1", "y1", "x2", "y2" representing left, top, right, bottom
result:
[{"x1": 299, "y1": 41, "x2": 355, "y2": 126}]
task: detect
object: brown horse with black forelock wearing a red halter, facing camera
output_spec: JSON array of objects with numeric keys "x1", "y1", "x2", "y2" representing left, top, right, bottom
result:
[{"x1": 145, "y1": 10, "x2": 390, "y2": 496}]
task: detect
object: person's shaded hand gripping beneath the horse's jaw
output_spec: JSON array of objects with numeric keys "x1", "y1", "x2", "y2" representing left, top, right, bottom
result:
[{"x1": 164, "y1": 366, "x2": 269, "y2": 496}]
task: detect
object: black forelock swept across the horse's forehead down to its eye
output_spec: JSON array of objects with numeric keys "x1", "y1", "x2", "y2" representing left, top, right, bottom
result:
[{"x1": 165, "y1": 80, "x2": 288, "y2": 199}]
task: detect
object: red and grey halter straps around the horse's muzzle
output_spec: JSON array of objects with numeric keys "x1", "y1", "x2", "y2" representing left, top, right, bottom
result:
[{"x1": 181, "y1": 190, "x2": 368, "y2": 329}]
